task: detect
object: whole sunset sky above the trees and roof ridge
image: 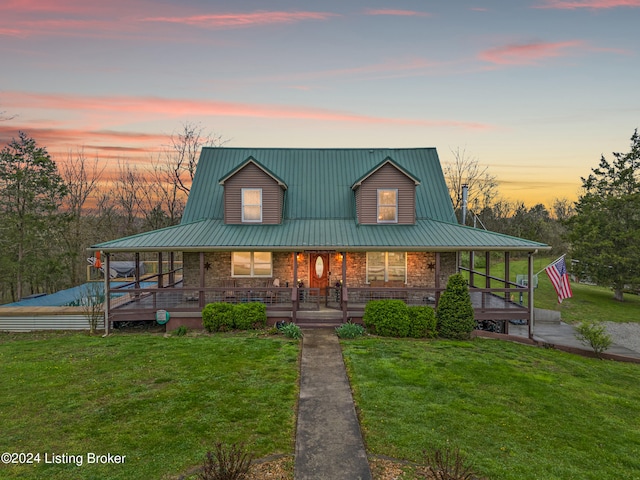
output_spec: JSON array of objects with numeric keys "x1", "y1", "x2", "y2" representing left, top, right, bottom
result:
[{"x1": 0, "y1": 0, "x2": 640, "y2": 205}]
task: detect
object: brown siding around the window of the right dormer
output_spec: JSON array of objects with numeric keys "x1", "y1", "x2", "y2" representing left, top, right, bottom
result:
[{"x1": 355, "y1": 164, "x2": 416, "y2": 225}]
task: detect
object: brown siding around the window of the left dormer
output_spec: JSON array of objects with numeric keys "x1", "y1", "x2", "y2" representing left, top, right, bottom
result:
[{"x1": 224, "y1": 163, "x2": 284, "y2": 225}]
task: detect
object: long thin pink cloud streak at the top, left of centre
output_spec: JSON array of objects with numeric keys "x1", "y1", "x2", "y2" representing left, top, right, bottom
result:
[{"x1": 143, "y1": 11, "x2": 337, "y2": 27}]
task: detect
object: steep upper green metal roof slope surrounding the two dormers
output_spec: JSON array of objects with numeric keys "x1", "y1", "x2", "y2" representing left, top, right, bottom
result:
[{"x1": 183, "y1": 147, "x2": 456, "y2": 223}]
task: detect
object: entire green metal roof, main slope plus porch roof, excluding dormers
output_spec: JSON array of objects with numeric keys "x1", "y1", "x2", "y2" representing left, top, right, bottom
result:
[{"x1": 91, "y1": 148, "x2": 549, "y2": 252}]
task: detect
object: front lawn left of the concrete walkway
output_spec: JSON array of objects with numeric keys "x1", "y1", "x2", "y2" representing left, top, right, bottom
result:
[{"x1": 0, "y1": 333, "x2": 299, "y2": 480}]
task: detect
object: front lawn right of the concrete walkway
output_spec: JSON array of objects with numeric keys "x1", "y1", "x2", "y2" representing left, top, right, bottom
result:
[{"x1": 343, "y1": 338, "x2": 640, "y2": 480}]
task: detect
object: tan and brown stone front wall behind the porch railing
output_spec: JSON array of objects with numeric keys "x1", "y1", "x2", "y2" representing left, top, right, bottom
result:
[{"x1": 183, "y1": 252, "x2": 457, "y2": 288}]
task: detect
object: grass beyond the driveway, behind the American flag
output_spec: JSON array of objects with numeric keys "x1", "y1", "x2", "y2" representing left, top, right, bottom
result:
[{"x1": 467, "y1": 256, "x2": 640, "y2": 323}]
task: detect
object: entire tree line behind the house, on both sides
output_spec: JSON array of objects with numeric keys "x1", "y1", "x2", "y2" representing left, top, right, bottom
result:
[{"x1": 0, "y1": 122, "x2": 640, "y2": 303}]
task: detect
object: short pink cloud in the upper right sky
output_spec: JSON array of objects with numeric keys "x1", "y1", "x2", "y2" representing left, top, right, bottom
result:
[{"x1": 479, "y1": 40, "x2": 583, "y2": 65}]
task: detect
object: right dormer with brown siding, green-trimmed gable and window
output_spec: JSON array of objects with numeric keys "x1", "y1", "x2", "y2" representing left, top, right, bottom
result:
[{"x1": 351, "y1": 157, "x2": 420, "y2": 225}]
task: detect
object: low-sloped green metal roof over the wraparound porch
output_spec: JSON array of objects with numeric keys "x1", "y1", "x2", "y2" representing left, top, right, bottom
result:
[{"x1": 89, "y1": 219, "x2": 550, "y2": 252}]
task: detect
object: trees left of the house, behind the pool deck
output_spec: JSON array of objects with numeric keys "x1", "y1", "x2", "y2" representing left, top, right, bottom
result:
[{"x1": 0, "y1": 122, "x2": 225, "y2": 303}]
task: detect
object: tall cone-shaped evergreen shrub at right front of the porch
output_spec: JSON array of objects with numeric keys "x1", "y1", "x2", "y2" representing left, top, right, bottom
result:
[{"x1": 436, "y1": 273, "x2": 476, "y2": 339}]
